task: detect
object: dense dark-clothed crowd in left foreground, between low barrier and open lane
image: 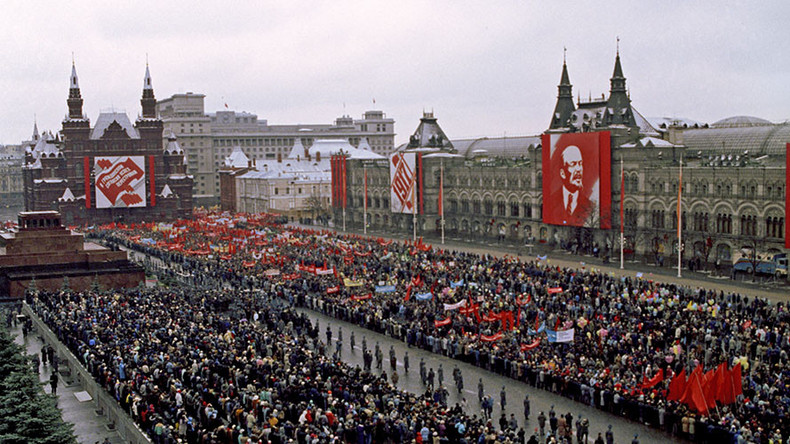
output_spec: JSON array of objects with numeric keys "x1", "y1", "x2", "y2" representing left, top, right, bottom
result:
[{"x1": 28, "y1": 289, "x2": 525, "y2": 444}]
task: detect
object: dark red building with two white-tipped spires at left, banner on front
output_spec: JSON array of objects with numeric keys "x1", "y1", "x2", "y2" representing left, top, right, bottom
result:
[{"x1": 23, "y1": 65, "x2": 193, "y2": 225}]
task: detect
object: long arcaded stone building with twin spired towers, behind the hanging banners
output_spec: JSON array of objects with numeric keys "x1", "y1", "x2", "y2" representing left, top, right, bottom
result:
[{"x1": 333, "y1": 53, "x2": 790, "y2": 266}]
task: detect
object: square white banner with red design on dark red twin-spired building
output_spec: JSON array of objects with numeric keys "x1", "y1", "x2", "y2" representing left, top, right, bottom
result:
[{"x1": 94, "y1": 156, "x2": 146, "y2": 208}]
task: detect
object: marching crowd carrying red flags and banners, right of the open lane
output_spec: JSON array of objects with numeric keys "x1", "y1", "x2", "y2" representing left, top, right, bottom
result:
[{"x1": 63, "y1": 212, "x2": 790, "y2": 442}]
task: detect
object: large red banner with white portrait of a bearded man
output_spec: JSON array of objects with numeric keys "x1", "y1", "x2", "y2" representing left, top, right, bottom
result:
[{"x1": 542, "y1": 131, "x2": 612, "y2": 228}]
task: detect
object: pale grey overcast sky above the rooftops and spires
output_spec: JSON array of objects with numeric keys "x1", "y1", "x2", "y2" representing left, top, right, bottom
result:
[{"x1": 0, "y1": 0, "x2": 790, "y2": 144}]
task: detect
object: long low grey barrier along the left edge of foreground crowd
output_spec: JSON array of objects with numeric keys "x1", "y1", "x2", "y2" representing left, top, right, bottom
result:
[{"x1": 22, "y1": 303, "x2": 152, "y2": 444}]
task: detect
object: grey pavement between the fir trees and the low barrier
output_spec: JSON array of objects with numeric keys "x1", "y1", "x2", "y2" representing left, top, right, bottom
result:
[{"x1": 10, "y1": 325, "x2": 124, "y2": 444}]
